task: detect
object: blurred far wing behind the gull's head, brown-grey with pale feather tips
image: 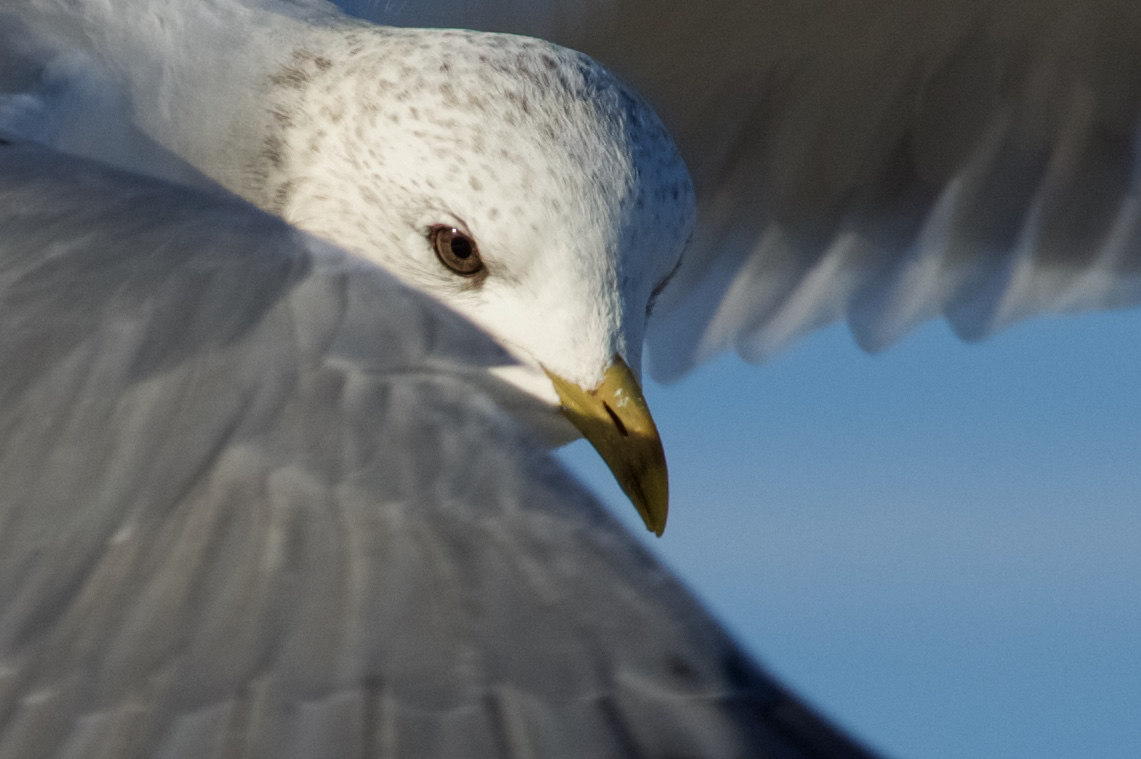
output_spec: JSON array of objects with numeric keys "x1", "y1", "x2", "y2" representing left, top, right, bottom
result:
[{"x1": 339, "y1": 0, "x2": 1141, "y2": 378}]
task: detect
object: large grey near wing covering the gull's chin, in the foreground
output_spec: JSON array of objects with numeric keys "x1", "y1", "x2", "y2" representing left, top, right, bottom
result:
[{"x1": 0, "y1": 145, "x2": 866, "y2": 759}]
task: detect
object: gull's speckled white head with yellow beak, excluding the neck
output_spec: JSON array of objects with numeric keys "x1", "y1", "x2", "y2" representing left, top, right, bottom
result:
[{"x1": 256, "y1": 29, "x2": 694, "y2": 534}]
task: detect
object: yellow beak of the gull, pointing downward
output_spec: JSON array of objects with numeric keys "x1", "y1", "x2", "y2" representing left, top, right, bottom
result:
[{"x1": 547, "y1": 356, "x2": 670, "y2": 536}]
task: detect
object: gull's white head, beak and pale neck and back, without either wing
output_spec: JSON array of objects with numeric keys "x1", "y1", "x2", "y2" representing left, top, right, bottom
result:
[{"x1": 7, "y1": 2, "x2": 694, "y2": 535}]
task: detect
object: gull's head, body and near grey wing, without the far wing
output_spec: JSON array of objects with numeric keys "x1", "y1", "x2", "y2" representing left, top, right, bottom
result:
[{"x1": 0, "y1": 2, "x2": 871, "y2": 757}]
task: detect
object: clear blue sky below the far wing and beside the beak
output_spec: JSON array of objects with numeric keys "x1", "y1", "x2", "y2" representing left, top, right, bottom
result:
[{"x1": 563, "y1": 312, "x2": 1141, "y2": 759}]
